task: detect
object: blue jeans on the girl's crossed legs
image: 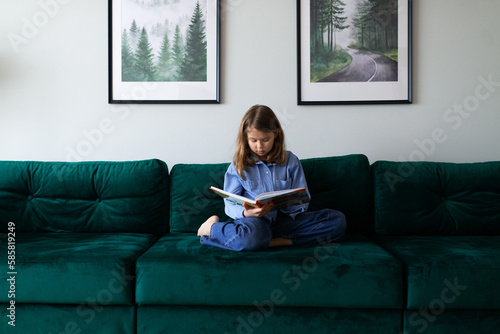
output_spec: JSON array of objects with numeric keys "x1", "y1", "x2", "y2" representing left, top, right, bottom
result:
[{"x1": 200, "y1": 209, "x2": 346, "y2": 251}]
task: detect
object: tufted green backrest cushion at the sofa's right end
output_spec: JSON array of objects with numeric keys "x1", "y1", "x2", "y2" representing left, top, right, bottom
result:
[{"x1": 372, "y1": 161, "x2": 500, "y2": 235}]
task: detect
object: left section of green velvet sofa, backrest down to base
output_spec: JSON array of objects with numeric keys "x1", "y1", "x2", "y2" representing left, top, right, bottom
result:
[{"x1": 0, "y1": 160, "x2": 169, "y2": 334}]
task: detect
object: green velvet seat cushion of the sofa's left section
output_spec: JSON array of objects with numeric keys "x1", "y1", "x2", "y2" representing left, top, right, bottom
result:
[{"x1": 0, "y1": 233, "x2": 157, "y2": 305}]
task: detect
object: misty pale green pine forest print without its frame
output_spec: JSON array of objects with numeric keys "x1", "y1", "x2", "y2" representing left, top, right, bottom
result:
[{"x1": 121, "y1": 0, "x2": 207, "y2": 82}]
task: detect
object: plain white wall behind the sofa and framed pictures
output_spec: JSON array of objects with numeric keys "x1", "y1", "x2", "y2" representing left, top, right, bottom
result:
[{"x1": 0, "y1": 0, "x2": 500, "y2": 167}]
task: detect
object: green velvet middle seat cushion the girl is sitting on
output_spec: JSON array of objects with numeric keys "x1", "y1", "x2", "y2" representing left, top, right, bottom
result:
[{"x1": 136, "y1": 234, "x2": 403, "y2": 308}]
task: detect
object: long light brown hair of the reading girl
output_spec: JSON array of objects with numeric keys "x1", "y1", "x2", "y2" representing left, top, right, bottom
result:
[{"x1": 233, "y1": 104, "x2": 287, "y2": 178}]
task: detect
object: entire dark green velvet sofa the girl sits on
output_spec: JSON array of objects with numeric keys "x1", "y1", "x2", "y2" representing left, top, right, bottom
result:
[{"x1": 0, "y1": 155, "x2": 500, "y2": 334}]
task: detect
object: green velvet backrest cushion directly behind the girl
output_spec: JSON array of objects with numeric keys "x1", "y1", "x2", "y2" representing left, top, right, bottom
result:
[{"x1": 170, "y1": 155, "x2": 373, "y2": 234}]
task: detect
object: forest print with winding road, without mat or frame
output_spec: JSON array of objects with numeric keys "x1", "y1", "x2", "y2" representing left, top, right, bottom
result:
[{"x1": 310, "y1": 0, "x2": 398, "y2": 83}]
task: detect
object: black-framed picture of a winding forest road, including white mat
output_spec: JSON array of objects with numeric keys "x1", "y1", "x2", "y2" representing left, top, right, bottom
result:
[{"x1": 297, "y1": 0, "x2": 412, "y2": 105}]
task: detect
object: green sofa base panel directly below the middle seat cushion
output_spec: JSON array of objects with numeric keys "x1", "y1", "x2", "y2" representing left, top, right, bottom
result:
[{"x1": 137, "y1": 303, "x2": 401, "y2": 334}]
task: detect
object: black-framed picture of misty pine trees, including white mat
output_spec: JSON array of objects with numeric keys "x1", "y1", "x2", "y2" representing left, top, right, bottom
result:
[{"x1": 108, "y1": 0, "x2": 220, "y2": 103}]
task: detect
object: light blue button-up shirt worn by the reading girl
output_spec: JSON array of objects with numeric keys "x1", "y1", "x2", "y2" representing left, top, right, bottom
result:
[{"x1": 224, "y1": 151, "x2": 310, "y2": 220}]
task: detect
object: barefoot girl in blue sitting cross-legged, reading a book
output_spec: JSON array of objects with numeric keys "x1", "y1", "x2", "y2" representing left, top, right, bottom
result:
[{"x1": 198, "y1": 105, "x2": 346, "y2": 251}]
